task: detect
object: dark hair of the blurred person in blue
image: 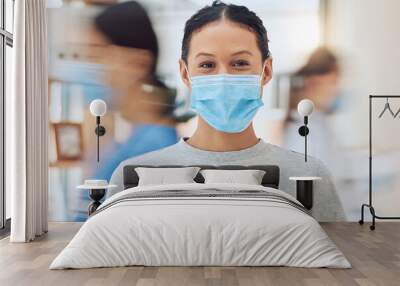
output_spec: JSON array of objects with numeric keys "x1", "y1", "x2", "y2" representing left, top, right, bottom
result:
[{"x1": 94, "y1": 1, "x2": 158, "y2": 72}]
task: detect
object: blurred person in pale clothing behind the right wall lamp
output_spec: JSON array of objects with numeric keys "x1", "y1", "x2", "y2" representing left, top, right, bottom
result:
[{"x1": 282, "y1": 47, "x2": 356, "y2": 217}]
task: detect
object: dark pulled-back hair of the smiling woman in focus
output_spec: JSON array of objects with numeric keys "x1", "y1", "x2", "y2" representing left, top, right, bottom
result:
[{"x1": 181, "y1": 1, "x2": 270, "y2": 63}]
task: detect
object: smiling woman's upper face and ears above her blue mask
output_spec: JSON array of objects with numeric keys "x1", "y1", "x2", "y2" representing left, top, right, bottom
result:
[{"x1": 179, "y1": 20, "x2": 272, "y2": 88}]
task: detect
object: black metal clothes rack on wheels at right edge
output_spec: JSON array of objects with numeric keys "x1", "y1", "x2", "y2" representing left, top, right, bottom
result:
[{"x1": 359, "y1": 95, "x2": 400, "y2": 230}]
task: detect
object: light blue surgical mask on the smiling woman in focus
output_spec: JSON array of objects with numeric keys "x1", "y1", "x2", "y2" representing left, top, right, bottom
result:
[{"x1": 190, "y1": 68, "x2": 263, "y2": 133}]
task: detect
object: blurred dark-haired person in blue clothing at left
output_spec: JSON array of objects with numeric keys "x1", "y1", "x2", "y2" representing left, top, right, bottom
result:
[{"x1": 86, "y1": 1, "x2": 192, "y2": 180}]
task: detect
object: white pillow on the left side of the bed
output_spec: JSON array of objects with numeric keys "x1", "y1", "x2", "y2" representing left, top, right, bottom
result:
[{"x1": 135, "y1": 167, "x2": 200, "y2": 186}]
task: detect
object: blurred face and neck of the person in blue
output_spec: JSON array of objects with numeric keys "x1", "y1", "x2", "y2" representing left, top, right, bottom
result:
[{"x1": 86, "y1": 26, "x2": 164, "y2": 121}]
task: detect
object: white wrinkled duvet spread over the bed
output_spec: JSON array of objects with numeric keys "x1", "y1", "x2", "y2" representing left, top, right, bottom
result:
[{"x1": 50, "y1": 183, "x2": 351, "y2": 269}]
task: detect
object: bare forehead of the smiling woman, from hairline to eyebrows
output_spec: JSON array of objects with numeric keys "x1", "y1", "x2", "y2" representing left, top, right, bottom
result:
[{"x1": 189, "y1": 20, "x2": 261, "y2": 58}]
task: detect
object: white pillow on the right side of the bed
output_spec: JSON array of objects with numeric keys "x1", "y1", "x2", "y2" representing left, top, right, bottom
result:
[{"x1": 200, "y1": 169, "x2": 265, "y2": 185}]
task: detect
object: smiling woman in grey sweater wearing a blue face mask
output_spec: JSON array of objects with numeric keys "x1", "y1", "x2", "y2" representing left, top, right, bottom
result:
[{"x1": 108, "y1": 1, "x2": 344, "y2": 221}]
